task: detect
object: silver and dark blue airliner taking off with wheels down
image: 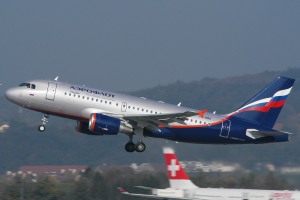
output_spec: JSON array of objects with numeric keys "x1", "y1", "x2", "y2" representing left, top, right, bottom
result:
[{"x1": 5, "y1": 76, "x2": 295, "y2": 152}]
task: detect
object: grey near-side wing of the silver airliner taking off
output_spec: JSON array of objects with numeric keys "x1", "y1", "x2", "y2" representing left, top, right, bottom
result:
[{"x1": 123, "y1": 111, "x2": 198, "y2": 131}]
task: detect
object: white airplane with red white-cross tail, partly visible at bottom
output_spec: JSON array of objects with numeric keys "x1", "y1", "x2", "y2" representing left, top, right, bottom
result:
[{"x1": 118, "y1": 147, "x2": 300, "y2": 200}]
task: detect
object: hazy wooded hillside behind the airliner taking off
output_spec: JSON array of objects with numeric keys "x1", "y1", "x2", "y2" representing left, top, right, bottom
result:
[{"x1": 0, "y1": 69, "x2": 300, "y2": 171}]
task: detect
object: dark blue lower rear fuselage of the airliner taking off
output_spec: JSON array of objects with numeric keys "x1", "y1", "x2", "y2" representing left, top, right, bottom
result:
[{"x1": 145, "y1": 117, "x2": 289, "y2": 144}]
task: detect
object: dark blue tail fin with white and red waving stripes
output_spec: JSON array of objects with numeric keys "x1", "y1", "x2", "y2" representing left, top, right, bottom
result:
[{"x1": 235, "y1": 76, "x2": 295, "y2": 128}]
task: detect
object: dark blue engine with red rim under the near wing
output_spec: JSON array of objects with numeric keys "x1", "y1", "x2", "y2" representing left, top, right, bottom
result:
[{"x1": 89, "y1": 113, "x2": 133, "y2": 135}]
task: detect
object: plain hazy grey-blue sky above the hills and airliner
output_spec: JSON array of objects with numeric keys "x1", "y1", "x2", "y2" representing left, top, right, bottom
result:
[{"x1": 0, "y1": 0, "x2": 300, "y2": 91}]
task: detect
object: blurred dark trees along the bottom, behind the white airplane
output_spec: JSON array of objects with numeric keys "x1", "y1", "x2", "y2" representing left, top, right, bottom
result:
[{"x1": 0, "y1": 168, "x2": 295, "y2": 200}]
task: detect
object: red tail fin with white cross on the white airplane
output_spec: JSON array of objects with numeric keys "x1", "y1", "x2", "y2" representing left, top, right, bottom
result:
[{"x1": 163, "y1": 147, "x2": 198, "y2": 189}]
